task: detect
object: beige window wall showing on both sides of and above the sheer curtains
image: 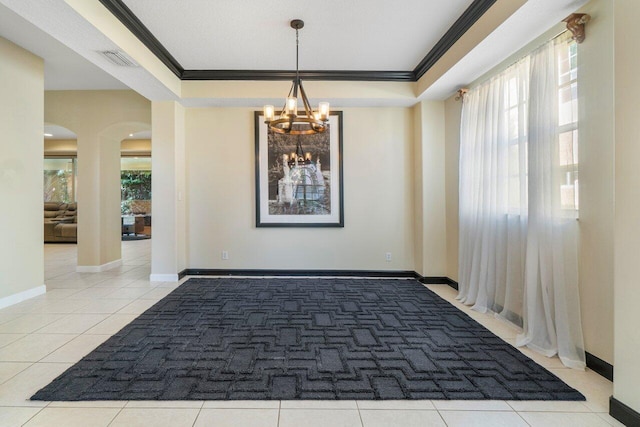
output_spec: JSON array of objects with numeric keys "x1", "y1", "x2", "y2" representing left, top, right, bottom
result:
[{"x1": 445, "y1": 0, "x2": 614, "y2": 363}]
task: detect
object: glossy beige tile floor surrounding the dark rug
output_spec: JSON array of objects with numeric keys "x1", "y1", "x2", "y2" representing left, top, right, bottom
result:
[{"x1": 0, "y1": 240, "x2": 622, "y2": 427}]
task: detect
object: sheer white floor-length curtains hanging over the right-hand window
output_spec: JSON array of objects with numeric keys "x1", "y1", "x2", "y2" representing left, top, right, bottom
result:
[{"x1": 458, "y1": 33, "x2": 585, "y2": 369}]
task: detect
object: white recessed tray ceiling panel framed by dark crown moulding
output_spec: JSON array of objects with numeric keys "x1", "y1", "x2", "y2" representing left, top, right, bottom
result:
[{"x1": 124, "y1": 0, "x2": 472, "y2": 71}]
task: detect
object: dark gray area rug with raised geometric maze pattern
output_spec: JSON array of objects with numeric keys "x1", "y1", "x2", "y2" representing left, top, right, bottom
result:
[{"x1": 31, "y1": 278, "x2": 584, "y2": 401}]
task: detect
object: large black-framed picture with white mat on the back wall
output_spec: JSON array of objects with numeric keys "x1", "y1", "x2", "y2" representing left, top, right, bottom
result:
[{"x1": 255, "y1": 111, "x2": 344, "y2": 227}]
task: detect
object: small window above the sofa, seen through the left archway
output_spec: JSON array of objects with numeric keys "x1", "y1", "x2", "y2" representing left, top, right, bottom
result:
[{"x1": 44, "y1": 157, "x2": 78, "y2": 203}]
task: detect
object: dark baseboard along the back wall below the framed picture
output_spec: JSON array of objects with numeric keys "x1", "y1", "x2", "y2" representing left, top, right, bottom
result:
[{"x1": 179, "y1": 268, "x2": 420, "y2": 279}]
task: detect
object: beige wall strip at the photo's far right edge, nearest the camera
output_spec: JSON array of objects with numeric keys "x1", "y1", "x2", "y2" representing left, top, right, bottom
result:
[{"x1": 613, "y1": 0, "x2": 640, "y2": 413}]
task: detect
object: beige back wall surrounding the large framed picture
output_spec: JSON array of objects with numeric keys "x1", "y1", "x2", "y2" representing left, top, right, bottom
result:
[{"x1": 185, "y1": 108, "x2": 414, "y2": 270}]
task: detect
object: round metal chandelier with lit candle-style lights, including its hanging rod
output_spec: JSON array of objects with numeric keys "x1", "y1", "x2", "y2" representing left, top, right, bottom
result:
[{"x1": 264, "y1": 19, "x2": 329, "y2": 135}]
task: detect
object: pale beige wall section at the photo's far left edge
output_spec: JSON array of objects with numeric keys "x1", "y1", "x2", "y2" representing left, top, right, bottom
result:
[{"x1": 0, "y1": 37, "x2": 44, "y2": 308}]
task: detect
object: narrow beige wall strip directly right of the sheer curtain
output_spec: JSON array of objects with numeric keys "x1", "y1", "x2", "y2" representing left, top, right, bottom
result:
[{"x1": 578, "y1": 0, "x2": 615, "y2": 364}]
